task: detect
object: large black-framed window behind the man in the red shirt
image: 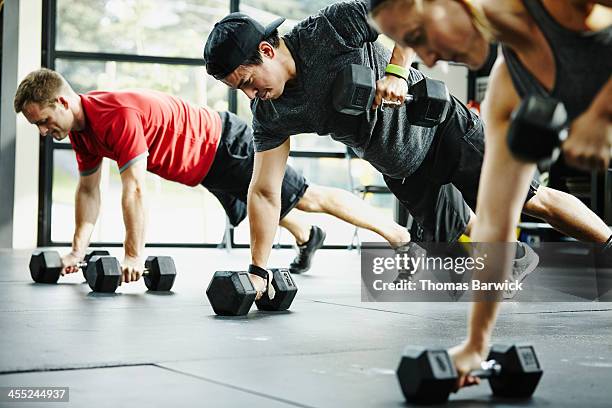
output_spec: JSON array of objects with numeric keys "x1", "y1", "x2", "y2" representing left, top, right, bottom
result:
[{"x1": 39, "y1": 0, "x2": 230, "y2": 245}]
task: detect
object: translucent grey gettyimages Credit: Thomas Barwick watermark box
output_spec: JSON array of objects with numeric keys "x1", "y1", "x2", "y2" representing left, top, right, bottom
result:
[{"x1": 361, "y1": 242, "x2": 612, "y2": 302}]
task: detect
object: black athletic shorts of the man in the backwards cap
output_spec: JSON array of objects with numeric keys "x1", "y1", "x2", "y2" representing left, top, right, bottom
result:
[{"x1": 384, "y1": 110, "x2": 539, "y2": 242}]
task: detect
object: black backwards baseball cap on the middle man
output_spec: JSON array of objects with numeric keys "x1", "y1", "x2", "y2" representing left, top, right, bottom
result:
[{"x1": 204, "y1": 13, "x2": 285, "y2": 79}]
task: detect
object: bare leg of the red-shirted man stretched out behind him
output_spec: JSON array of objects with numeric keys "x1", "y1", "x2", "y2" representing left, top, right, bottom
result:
[{"x1": 292, "y1": 185, "x2": 410, "y2": 246}]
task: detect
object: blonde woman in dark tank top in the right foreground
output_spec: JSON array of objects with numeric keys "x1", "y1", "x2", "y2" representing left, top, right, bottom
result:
[{"x1": 370, "y1": 0, "x2": 612, "y2": 388}]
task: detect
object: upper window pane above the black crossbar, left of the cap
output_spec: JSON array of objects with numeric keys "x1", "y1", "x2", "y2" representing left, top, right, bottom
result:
[{"x1": 56, "y1": 0, "x2": 230, "y2": 58}]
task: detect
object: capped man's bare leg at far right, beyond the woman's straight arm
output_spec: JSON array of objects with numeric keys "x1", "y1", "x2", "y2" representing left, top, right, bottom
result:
[{"x1": 523, "y1": 187, "x2": 612, "y2": 243}]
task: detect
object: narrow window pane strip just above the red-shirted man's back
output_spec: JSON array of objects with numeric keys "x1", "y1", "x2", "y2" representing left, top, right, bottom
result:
[{"x1": 55, "y1": 59, "x2": 227, "y2": 110}]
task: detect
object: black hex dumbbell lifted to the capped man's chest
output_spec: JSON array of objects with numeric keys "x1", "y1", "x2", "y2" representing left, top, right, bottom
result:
[{"x1": 332, "y1": 64, "x2": 450, "y2": 127}]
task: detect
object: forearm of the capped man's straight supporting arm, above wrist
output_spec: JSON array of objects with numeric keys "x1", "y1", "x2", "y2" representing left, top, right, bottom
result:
[{"x1": 247, "y1": 190, "x2": 280, "y2": 268}]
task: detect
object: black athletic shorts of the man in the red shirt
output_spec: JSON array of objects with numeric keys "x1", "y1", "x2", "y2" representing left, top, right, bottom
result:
[{"x1": 201, "y1": 112, "x2": 308, "y2": 226}]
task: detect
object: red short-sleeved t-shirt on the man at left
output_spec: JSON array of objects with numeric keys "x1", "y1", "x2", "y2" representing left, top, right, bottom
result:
[{"x1": 69, "y1": 90, "x2": 221, "y2": 186}]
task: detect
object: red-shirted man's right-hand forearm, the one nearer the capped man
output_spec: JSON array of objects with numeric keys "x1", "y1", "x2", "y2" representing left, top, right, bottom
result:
[{"x1": 121, "y1": 188, "x2": 146, "y2": 258}]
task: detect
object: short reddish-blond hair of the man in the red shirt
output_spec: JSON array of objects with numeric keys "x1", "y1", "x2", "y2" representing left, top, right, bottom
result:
[{"x1": 13, "y1": 68, "x2": 69, "y2": 113}]
